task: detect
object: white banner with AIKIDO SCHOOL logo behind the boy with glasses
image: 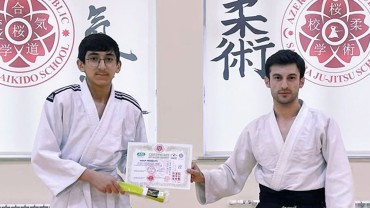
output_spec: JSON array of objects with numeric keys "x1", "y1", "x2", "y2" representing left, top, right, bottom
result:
[{"x1": 0, "y1": 0, "x2": 156, "y2": 155}]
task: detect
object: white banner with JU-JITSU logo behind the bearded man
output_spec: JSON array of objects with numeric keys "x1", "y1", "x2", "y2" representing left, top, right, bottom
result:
[{"x1": 204, "y1": 0, "x2": 370, "y2": 155}]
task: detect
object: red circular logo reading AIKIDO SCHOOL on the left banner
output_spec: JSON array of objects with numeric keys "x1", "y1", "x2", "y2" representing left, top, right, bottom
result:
[{"x1": 0, "y1": 0, "x2": 75, "y2": 87}]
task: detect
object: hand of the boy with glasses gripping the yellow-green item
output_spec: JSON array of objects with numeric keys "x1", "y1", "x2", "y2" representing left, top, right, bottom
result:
[{"x1": 80, "y1": 169, "x2": 125, "y2": 194}]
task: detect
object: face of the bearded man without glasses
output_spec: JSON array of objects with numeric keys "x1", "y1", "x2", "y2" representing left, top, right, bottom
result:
[{"x1": 265, "y1": 64, "x2": 304, "y2": 104}]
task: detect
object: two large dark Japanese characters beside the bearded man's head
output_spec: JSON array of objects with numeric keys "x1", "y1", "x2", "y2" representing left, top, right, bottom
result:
[{"x1": 211, "y1": 0, "x2": 275, "y2": 80}]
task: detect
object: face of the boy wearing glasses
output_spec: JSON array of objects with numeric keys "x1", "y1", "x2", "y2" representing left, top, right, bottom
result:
[{"x1": 77, "y1": 51, "x2": 121, "y2": 87}]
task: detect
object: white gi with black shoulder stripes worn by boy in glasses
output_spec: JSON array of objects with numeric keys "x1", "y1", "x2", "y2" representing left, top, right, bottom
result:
[{"x1": 31, "y1": 81, "x2": 147, "y2": 208}]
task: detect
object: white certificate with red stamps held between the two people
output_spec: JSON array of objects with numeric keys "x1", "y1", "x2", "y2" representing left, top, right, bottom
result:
[{"x1": 126, "y1": 142, "x2": 192, "y2": 189}]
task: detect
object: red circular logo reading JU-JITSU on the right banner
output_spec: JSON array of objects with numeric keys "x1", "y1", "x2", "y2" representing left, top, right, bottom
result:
[{"x1": 281, "y1": 0, "x2": 370, "y2": 87}]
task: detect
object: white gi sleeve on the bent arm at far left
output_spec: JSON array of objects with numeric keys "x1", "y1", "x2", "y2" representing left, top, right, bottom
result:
[{"x1": 31, "y1": 100, "x2": 86, "y2": 196}]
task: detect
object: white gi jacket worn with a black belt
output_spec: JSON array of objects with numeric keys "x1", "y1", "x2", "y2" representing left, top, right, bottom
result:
[{"x1": 196, "y1": 101, "x2": 355, "y2": 208}]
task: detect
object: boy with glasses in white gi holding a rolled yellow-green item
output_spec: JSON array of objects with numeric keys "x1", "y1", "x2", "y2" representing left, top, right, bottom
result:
[{"x1": 31, "y1": 33, "x2": 147, "y2": 208}]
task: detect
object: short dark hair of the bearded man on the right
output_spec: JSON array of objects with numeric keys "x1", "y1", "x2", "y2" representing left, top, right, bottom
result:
[{"x1": 265, "y1": 50, "x2": 306, "y2": 78}]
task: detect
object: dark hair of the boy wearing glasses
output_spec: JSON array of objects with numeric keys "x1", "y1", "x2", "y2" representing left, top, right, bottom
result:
[{"x1": 78, "y1": 33, "x2": 120, "y2": 63}]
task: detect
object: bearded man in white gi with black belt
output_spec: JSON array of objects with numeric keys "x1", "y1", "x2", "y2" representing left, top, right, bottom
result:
[{"x1": 187, "y1": 50, "x2": 355, "y2": 208}]
